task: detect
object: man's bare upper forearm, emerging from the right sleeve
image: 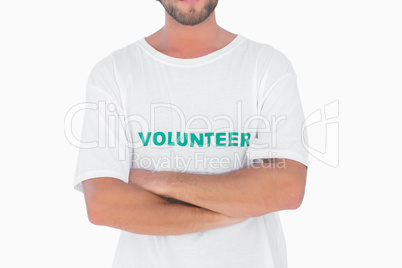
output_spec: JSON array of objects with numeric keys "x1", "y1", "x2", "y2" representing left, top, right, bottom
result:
[{"x1": 130, "y1": 160, "x2": 306, "y2": 217}]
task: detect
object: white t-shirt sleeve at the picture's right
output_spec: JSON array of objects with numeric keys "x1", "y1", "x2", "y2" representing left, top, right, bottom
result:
[{"x1": 247, "y1": 52, "x2": 309, "y2": 166}]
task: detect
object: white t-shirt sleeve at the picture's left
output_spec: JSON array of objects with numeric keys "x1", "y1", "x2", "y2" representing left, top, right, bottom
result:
[{"x1": 74, "y1": 55, "x2": 131, "y2": 192}]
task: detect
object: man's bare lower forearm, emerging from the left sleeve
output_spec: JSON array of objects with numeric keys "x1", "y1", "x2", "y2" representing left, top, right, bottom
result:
[{"x1": 83, "y1": 178, "x2": 244, "y2": 235}]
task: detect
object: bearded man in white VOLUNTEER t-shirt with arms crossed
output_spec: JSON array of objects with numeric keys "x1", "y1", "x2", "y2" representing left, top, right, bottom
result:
[{"x1": 74, "y1": 0, "x2": 308, "y2": 268}]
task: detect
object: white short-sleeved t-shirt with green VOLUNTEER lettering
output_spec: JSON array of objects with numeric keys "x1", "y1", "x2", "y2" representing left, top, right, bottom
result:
[{"x1": 74, "y1": 35, "x2": 308, "y2": 268}]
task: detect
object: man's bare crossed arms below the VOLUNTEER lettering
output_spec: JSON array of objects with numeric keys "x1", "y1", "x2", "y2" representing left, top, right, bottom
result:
[{"x1": 83, "y1": 159, "x2": 307, "y2": 235}]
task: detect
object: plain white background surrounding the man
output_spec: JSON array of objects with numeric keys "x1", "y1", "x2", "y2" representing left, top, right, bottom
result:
[{"x1": 0, "y1": 0, "x2": 402, "y2": 268}]
